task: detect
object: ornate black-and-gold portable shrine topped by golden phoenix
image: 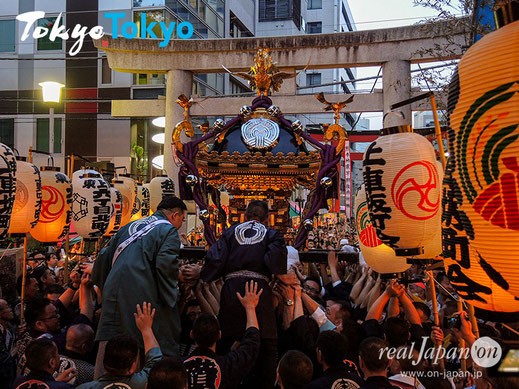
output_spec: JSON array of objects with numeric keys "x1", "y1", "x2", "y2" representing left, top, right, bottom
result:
[{"x1": 172, "y1": 48, "x2": 351, "y2": 248}]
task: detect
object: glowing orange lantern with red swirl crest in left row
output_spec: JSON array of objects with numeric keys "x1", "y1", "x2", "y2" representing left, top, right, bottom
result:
[{"x1": 31, "y1": 166, "x2": 72, "y2": 243}]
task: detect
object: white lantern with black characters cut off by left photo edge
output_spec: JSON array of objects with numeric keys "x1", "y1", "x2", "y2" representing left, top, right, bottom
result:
[{"x1": 0, "y1": 143, "x2": 16, "y2": 240}]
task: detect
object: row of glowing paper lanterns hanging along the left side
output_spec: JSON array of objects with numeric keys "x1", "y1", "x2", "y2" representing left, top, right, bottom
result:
[{"x1": 0, "y1": 144, "x2": 179, "y2": 243}]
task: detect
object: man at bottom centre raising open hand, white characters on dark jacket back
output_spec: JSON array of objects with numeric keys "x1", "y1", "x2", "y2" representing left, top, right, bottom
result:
[{"x1": 184, "y1": 281, "x2": 262, "y2": 389}]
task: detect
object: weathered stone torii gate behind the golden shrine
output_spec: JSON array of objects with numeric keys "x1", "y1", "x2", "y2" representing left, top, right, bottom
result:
[{"x1": 94, "y1": 22, "x2": 467, "y2": 187}]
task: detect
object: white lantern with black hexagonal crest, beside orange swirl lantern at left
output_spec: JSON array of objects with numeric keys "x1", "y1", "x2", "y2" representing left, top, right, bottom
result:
[{"x1": 72, "y1": 169, "x2": 112, "y2": 240}]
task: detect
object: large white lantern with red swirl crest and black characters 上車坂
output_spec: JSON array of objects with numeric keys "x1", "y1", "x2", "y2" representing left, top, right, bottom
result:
[{"x1": 363, "y1": 126, "x2": 441, "y2": 256}]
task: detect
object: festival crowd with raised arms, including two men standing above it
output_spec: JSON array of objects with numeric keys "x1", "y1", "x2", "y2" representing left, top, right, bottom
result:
[{"x1": 0, "y1": 197, "x2": 519, "y2": 389}]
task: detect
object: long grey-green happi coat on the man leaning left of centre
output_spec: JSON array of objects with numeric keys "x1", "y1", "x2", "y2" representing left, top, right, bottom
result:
[{"x1": 92, "y1": 210, "x2": 181, "y2": 355}]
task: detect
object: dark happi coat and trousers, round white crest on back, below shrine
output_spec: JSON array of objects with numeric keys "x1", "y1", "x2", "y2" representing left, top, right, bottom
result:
[{"x1": 200, "y1": 220, "x2": 287, "y2": 339}]
